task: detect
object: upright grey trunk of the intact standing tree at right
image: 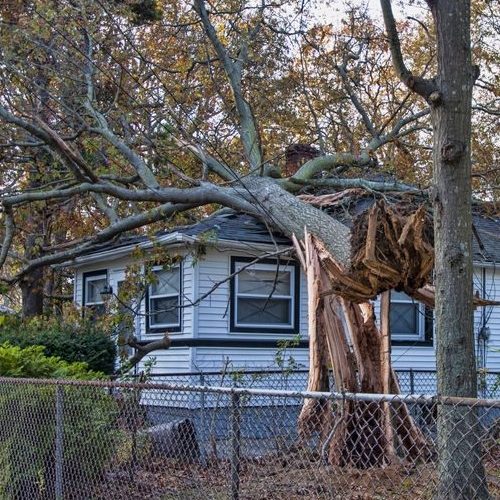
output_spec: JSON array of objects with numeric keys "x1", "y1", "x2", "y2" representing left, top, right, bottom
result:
[{"x1": 429, "y1": 0, "x2": 488, "y2": 500}]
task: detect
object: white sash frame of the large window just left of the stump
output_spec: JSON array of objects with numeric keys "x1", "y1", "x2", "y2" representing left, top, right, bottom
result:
[{"x1": 233, "y1": 260, "x2": 296, "y2": 330}]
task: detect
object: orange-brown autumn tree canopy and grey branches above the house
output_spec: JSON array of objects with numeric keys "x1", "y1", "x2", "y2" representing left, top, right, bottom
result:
[{"x1": 0, "y1": 0, "x2": 499, "y2": 308}]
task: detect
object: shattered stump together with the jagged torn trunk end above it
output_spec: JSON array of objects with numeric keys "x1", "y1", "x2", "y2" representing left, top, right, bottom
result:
[{"x1": 294, "y1": 191, "x2": 495, "y2": 468}]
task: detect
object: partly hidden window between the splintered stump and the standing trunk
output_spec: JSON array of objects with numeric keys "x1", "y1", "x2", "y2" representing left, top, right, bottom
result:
[{"x1": 390, "y1": 291, "x2": 432, "y2": 343}]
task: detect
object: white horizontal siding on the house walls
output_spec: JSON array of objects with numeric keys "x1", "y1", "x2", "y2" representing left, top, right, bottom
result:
[{"x1": 74, "y1": 248, "x2": 500, "y2": 372}]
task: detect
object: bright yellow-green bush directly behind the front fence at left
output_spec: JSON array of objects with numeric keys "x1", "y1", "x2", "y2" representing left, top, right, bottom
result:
[{"x1": 0, "y1": 344, "x2": 123, "y2": 500}]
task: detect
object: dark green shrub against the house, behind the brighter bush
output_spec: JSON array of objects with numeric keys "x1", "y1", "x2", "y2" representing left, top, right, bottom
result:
[{"x1": 0, "y1": 316, "x2": 116, "y2": 375}]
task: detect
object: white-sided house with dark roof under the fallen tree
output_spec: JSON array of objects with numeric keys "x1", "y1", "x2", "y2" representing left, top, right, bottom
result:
[{"x1": 71, "y1": 212, "x2": 500, "y2": 392}]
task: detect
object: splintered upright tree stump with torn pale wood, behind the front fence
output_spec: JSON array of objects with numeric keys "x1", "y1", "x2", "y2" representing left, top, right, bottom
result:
[{"x1": 295, "y1": 230, "x2": 431, "y2": 469}]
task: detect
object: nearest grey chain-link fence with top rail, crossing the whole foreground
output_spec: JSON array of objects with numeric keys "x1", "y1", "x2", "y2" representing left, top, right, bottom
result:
[{"x1": 0, "y1": 378, "x2": 500, "y2": 500}]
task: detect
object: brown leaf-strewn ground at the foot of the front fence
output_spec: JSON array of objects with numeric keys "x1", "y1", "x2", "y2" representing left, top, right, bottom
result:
[{"x1": 90, "y1": 452, "x2": 500, "y2": 500}]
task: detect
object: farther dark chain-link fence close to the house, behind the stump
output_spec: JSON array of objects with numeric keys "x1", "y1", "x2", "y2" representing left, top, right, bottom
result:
[{"x1": 131, "y1": 367, "x2": 500, "y2": 398}]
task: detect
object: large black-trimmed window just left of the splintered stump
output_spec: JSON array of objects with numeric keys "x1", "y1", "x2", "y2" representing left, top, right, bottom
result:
[{"x1": 231, "y1": 259, "x2": 299, "y2": 333}]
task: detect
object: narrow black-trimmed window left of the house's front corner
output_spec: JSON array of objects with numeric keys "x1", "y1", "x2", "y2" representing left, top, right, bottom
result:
[{"x1": 146, "y1": 265, "x2": 181, "y2": 331}]
